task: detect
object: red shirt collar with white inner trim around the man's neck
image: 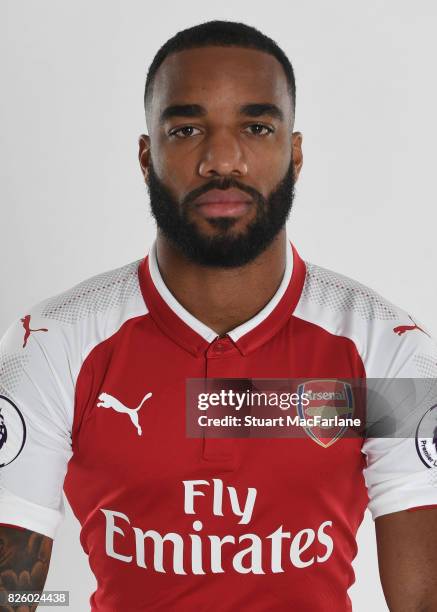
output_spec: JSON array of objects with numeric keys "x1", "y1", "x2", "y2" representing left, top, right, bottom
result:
[{"x1": 138, "y1": 237, "x2": 306, "y2": 355}]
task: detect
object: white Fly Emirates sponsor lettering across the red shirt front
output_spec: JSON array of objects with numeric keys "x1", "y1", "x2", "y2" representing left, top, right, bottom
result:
[{"x1": 100, "y1": 478, "x2": 334, "y2": 575}]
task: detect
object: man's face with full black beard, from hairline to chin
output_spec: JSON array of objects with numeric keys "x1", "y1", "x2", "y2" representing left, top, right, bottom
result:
[{"x1": 140, "y1": 47, "x2": 302, "y2": 267}]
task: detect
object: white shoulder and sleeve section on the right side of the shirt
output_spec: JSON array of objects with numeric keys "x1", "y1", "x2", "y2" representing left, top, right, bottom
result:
[{"x1": 294, "y1": 264, "x2": 437, "y2": 519}]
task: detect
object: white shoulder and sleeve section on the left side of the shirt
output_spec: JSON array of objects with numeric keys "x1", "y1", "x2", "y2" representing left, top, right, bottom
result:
[{"x1": 0, "y1": 262, "x2": 147, "y2": 537}]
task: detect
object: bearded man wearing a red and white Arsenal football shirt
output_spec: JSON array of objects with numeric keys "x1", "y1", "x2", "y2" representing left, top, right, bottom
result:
[{"x1": 0, "y1": 22, "x2": 437, "y2": 612}]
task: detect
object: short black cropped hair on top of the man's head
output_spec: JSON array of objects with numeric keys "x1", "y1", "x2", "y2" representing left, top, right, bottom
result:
[{"x1": 144, "y1": 20, "x2": 296, "y2": 114}]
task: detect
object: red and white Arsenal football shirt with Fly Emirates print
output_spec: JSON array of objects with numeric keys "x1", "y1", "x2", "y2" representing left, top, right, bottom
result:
[{"x1": 0, "y1": 244, "x2": 437, "y2": 612}]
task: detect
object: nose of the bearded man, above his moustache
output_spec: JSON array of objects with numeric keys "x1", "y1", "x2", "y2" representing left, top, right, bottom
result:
[{"x1": 199, "y1": 130, "x2": 248, "y2": 178}]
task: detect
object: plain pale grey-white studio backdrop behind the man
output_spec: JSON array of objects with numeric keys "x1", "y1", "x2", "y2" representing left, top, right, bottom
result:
[{"x1": 0, "y1": 0, "x2": 437, "y2": 612}]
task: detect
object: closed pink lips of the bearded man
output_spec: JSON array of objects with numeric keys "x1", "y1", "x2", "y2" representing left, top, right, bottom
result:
[{"x1": 194, "y1": 189, "x2": 252, "y2": 218}]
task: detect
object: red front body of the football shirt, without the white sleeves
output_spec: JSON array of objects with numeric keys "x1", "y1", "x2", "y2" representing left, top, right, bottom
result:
[{"x1": 64, "y1": 244, "x2": 368, "y2": 612}]
